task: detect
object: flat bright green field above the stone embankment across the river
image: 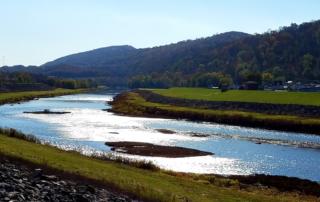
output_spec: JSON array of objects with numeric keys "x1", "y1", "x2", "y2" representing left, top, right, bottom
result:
[{"x1": 152, "y1": 88, "x2": 320, "y2": 106}]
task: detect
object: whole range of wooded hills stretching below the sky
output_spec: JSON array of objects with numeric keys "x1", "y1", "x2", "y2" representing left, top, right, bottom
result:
[{"x1": 2, "y1": 21, "x2": 320, "y2": 86}]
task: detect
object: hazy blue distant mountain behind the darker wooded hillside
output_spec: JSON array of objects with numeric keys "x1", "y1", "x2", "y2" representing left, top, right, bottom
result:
[{"x1": 41, "y1": 32, "x2": 250, "y2": 82}]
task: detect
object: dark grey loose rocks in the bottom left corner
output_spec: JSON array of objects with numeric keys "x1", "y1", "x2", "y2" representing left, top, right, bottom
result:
[{"x1": 0, "y1": 158, "x2": 133, "y2": 202}]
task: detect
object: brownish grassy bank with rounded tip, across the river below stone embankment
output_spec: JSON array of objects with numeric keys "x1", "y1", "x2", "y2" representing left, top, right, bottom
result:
[{"x1": 111, "y1": 92, "x2": 320, "y2": 134}]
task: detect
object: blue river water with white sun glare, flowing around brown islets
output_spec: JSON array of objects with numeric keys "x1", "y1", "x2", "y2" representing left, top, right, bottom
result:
[{"x1": 0, "y1": 92, "x2": 320, "y2": 181}]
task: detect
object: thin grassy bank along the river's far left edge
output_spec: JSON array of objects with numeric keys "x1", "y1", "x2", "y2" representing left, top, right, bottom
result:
[{"x1": 0, "y1": 88, "x2": 86, "y2": 104}]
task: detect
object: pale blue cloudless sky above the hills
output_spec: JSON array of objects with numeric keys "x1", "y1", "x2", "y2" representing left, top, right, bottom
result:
[{"x1": 0, "y1": 0, "x2": 320, "y2": 66}]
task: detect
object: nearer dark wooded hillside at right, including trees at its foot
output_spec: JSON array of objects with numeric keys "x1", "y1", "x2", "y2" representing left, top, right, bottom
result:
[{"x1": 129, "y1": 21, "x2": 320, "y2": 87}]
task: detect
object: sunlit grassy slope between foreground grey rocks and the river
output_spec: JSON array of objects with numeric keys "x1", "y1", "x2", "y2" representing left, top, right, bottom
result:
[{"x1": 0, "y1": 135, "x2": 316, "y2": 201}]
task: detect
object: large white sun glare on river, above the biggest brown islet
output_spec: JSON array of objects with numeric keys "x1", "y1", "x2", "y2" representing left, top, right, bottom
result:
[{"x1": 21, "y1": 109, "x2": 196, "y2": 145}]
